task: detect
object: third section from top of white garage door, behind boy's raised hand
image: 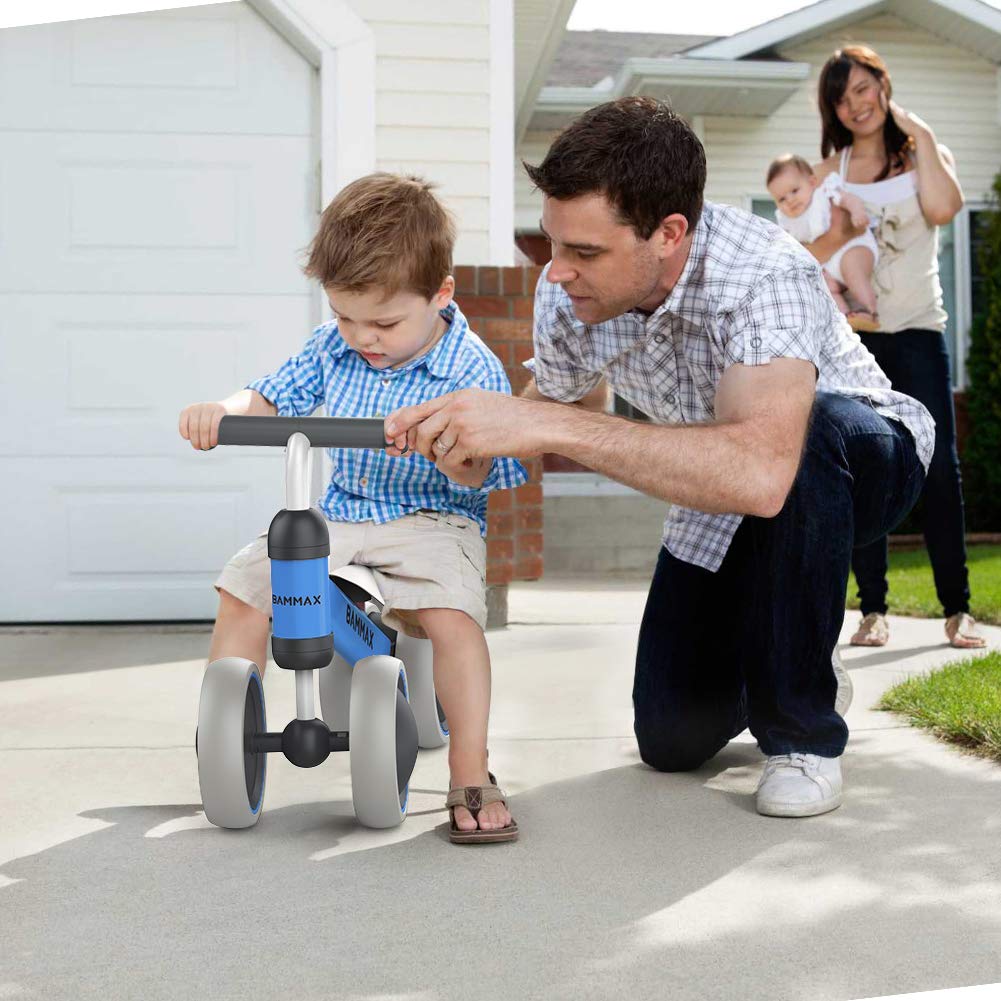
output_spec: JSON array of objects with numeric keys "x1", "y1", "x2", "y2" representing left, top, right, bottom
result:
[{"x1": 0, "y1": 295, "x2": 314, "y2": 457}]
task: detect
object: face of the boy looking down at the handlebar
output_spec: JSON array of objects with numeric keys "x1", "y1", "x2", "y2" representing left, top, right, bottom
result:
[{"x1": 325, "y1": 275, "x2": 455, "y2": 368}]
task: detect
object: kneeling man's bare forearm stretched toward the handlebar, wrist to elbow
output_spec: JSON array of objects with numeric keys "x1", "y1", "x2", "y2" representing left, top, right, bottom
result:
[{"x1": 544, "y1": 404, "x2": 799, "y2": 518}]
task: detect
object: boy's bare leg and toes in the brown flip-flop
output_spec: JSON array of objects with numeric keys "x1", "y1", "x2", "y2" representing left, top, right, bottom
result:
[{"x1": 416, "y1": 609, "x2": 511, "y2": 831}]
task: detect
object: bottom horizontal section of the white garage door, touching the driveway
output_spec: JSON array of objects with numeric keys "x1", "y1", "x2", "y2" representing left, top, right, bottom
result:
[{"x1": 0, "y1": 452, "x2": 283, "y2": 622}]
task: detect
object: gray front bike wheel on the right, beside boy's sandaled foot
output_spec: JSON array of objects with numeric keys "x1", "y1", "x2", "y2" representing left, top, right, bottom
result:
[{"x1": 348, "y1": 655, "x2": 417, "y2": 828}]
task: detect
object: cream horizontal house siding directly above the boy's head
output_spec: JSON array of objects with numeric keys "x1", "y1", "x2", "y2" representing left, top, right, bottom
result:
[{"x1": 366, "y1": 0, "x2": 490, "y2": 264}]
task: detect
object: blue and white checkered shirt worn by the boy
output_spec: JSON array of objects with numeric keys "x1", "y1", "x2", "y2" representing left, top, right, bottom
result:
[{"x1": 247, "y1": 303, "x2": 529, "y2": 536}]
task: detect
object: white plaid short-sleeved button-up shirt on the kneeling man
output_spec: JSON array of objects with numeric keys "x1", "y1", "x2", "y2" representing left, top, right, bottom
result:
[{"x1": 531, "y1": 203, "x2": 935, "y2": 571}]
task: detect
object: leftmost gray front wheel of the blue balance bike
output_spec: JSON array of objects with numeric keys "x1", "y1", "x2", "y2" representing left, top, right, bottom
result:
[{"x1": 196, "y1": 657, "x2": 267, "y2": 828}]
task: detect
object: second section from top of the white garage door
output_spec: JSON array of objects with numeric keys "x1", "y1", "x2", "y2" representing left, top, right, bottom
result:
[{"x1": 0, "y1": 132, "x2": 316, "y2": 294}]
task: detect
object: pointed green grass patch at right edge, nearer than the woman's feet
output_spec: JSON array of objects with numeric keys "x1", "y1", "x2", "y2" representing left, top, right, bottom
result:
[{"x1": 877, "y1": 651, "x2": 1001, "y2": 761}]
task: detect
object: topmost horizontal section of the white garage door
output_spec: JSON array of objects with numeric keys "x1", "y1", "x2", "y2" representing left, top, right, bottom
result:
[{"x1": 0, "y1": 4, "x2": 313, "y2": 136}]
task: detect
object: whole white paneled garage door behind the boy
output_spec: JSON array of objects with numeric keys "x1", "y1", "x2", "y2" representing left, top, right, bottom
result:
[{"x1": 0, "y1": 3, "x2": 317, "y2": 622}]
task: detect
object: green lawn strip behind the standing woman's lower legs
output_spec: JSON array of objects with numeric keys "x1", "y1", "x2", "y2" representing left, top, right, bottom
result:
[{"x1": 848, "y1": 546, "x2": 1001, "y2": 626}]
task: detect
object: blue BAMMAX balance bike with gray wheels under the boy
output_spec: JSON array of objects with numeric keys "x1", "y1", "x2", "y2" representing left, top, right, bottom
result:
[{"x1": 195, "y1": 416, "x2": 448, "y2": 828}]
